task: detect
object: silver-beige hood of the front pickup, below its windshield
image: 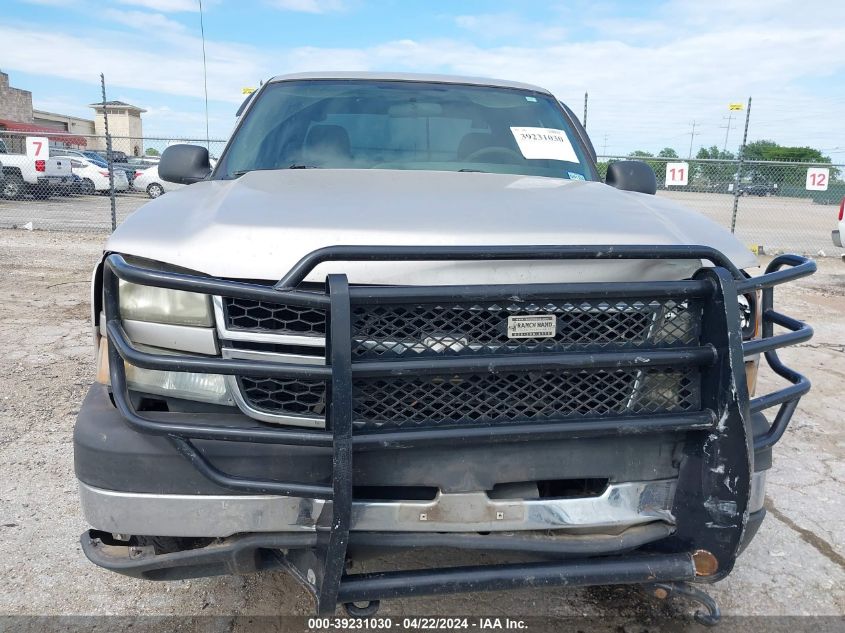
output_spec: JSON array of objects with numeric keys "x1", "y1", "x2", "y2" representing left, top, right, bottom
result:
[{"x1": 107, "y1": 169, "x2": 757, "y2": 284}]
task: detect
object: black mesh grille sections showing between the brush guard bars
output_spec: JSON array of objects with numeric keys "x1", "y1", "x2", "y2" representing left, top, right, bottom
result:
[{"x1": 224, "y1": 297, "x2": 702, "y2": 429}]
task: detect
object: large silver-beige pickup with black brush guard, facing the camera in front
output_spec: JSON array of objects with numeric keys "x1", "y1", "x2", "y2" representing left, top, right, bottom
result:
[{"x1": 74, "y1": 73, "x2": 815, "y2": 622}]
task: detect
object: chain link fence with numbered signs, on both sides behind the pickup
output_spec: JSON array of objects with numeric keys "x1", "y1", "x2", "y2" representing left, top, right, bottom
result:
[{"x1": 0, "y1": 131, "x2": 845, "y2": 256}]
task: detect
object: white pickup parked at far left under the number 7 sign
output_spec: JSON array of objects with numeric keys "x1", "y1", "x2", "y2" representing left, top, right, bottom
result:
[{"x1": 0, "y1": 139, "x2": 73, "y2": 200}]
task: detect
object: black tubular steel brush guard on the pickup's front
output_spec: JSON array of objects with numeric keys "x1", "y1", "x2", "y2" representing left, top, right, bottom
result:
[{"x1": 90, "y1": 246, "x2": 815, "y2": 616}]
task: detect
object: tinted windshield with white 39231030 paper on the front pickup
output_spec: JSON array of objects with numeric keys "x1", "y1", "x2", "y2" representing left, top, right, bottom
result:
[{"x1": 215, "y1": 80, "x2": 594, "y2": 180}]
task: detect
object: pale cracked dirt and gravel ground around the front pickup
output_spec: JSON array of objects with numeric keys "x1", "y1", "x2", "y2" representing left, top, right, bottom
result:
[{"x1": 0, "y1": 230, "x2": 845, "y2": 631}]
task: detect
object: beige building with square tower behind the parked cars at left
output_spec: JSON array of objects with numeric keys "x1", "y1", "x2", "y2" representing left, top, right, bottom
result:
[{"x1": 0, "y1": 72, "x2": 146, "y2": 156}]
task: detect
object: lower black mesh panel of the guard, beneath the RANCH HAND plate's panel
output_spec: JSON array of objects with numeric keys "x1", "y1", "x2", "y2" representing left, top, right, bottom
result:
[{"x1": 353, "y1": 369, "x2": 700, "y2": 428}]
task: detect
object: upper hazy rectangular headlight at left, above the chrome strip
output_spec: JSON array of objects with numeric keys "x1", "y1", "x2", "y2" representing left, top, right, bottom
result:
[{"x1": 120, "y1": 279, "x2": 214, "y2": 327}]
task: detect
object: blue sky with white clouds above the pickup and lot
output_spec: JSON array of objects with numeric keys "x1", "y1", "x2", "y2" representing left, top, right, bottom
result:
[{"x1": 0, "y1": 0, "x2": 845, "y2": 158}]
